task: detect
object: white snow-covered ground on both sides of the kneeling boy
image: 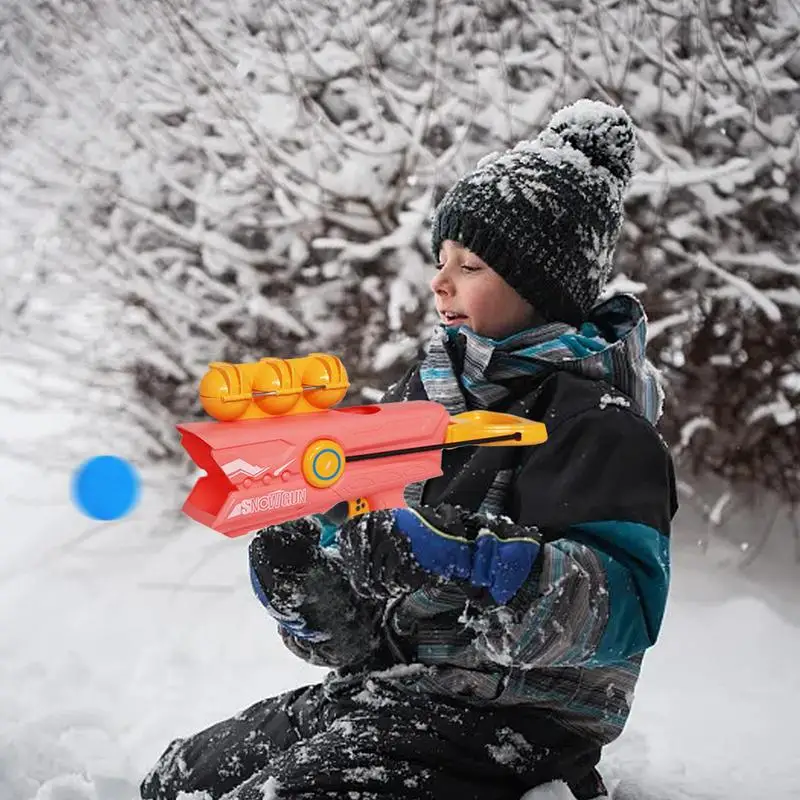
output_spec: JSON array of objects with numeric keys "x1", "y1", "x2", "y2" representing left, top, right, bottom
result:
[{"x1": 0, "y1": 417, "x2": 800, "y2": 800}]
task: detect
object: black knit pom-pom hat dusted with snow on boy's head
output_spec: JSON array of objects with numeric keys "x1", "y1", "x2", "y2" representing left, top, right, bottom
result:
[{"x1": 432, "y1": 100, "x2": 636, "y2": 325}]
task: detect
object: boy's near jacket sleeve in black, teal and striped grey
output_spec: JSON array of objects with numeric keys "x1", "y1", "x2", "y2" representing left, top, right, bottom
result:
[{"x1": 476, "y1": 406, "x2": 675, "y2": 668}]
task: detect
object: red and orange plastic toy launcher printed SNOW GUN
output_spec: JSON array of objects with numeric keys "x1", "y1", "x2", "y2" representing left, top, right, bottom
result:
[{"x1": 178, "y1": 353, "x2": 547, "y2": 536}]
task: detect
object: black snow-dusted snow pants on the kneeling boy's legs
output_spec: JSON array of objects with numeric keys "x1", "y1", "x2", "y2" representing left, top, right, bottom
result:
[{"x1": 141, "y1": 685, "x2": 605, "y2": 800}]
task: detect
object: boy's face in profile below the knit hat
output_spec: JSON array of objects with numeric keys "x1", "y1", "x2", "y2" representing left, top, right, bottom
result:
[{"x1": 431, "y1": 239, "x2": 536, "y2": 339}]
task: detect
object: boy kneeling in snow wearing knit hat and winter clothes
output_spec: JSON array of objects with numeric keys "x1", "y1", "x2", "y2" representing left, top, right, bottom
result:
[{"x1": 142, "y1": 101, "x2": 677, "y2": 800}]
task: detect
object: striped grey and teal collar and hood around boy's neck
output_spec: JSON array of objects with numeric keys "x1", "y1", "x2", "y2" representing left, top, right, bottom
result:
[{"x1": 406, "y1": 295, "x2": 663, "y2": 513}]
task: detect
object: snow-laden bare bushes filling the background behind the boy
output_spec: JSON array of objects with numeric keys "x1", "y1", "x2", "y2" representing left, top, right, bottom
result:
[{"x1": 0, "y1": 0, "x2": 800, "y2": 506}]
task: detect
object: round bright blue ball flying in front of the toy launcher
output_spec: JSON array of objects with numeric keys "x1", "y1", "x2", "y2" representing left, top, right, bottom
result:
[{"x1": 72, "y1": 456, "x2": 140, "y2": 521}]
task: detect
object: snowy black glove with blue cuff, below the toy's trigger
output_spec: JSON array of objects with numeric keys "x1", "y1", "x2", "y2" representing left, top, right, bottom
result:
[{"x1": 339, "y1": 505, "x2": 540, "y2": 603}]
